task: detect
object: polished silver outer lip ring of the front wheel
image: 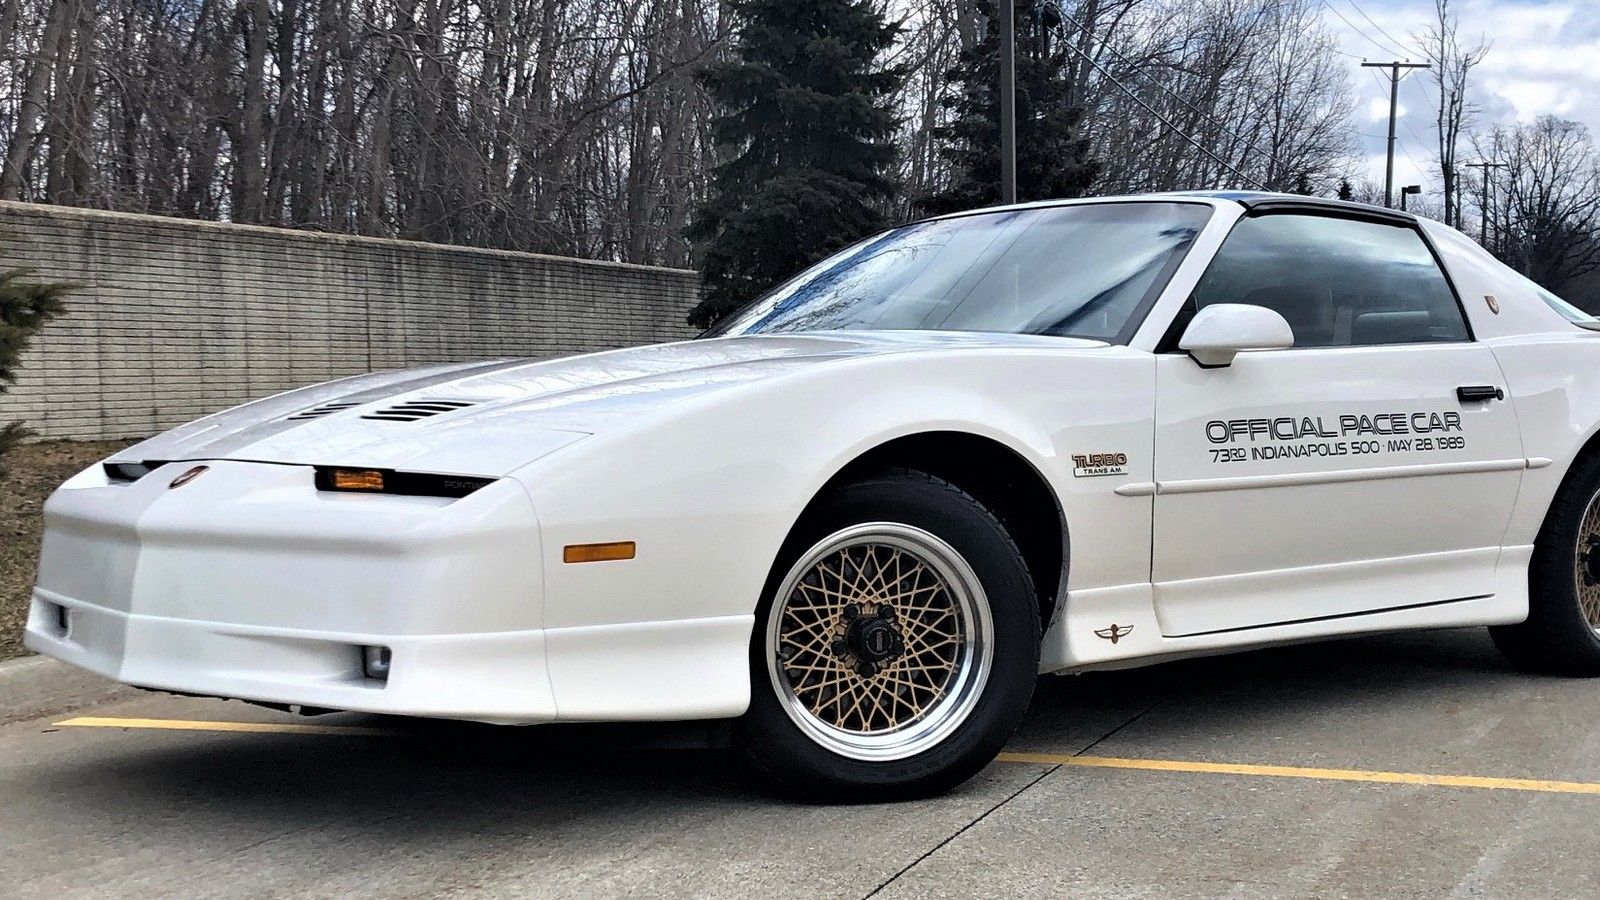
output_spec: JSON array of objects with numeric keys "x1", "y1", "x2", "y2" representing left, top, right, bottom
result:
[{"x1": 762, "y1": 522, "x2": 994, "y2": 762}]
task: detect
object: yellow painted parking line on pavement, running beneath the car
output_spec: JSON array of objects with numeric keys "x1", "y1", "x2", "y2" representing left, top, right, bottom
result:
[{"x1": 56, "y1": 716, "x2": 1600, "y2": 794}]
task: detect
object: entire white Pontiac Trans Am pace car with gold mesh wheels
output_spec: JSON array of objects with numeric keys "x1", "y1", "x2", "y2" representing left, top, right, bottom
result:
[{"x1": 27, "y1": 194, "x2": 1600, "y2": 799}]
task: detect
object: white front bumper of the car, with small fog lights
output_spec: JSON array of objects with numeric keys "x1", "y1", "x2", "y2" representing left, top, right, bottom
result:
[{"x1": 26, "y1": 461, "x2": 557, "y2": 722}]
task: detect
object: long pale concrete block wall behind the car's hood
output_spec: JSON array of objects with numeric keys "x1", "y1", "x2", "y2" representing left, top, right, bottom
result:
[{"x1": 0, "y1": 202, "x2": 699, "y2": 440}]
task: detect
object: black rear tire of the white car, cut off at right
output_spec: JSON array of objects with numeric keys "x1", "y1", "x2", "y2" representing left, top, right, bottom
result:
[{"x1": 1490, "y1": 456, "x2": 1600, "y2": 677}]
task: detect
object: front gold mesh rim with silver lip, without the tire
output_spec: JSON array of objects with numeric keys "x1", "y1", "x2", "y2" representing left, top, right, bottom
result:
[{"x1": 766, "y1": 522, "x2": 992, "y2": 761}]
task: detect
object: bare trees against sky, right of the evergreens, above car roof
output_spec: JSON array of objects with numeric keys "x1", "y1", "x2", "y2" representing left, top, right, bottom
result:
[{"x1": 1067, "y1": 0, "x2": 1355, "y2": 194}]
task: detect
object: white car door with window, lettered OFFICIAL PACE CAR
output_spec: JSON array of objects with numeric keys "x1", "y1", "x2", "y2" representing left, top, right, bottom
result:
[{"x1": 1152, "y1": 211, "x2": 1525, "y2": 636}]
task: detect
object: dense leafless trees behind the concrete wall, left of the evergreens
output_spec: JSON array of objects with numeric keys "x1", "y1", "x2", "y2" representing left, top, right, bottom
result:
[{"x1": 0, "y1": 0, "x2": 725, "y2": 264}]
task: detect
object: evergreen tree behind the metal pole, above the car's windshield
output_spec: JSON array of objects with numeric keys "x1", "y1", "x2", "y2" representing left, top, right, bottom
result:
[{"x1": 920, "y1": 0, "x2": 1099, "y2": 215}]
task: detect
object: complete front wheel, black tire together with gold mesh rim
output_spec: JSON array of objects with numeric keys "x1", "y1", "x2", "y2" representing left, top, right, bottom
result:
[{"x1": 739, "y1": 469, "x2": 1040, "y2": 802}]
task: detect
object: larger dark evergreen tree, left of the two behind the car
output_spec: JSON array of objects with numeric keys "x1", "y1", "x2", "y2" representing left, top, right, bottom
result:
[{"x1": 690, "y1": 0, "x2": 906, "y2": 327}]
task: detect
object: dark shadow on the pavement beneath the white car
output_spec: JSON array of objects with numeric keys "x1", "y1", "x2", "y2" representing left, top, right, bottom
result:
[{"x1": 34, "y1": 629, "x2": 1531, "y2": 834}]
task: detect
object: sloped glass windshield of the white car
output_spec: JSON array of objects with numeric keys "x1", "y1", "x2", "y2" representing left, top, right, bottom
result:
[{"x1": 707, "y1": 202, "x2": 1211, "y2": 341}]
